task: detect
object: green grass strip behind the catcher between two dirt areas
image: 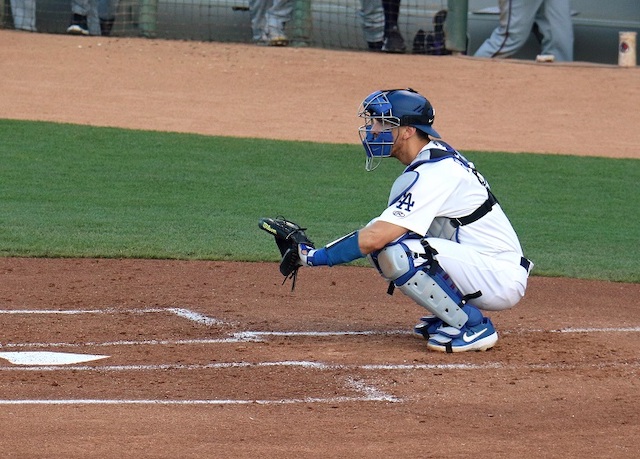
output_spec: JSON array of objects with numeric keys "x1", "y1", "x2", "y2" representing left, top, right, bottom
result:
[{"x1": 0, "y1": 120, "x2": 640, "y2": 282}]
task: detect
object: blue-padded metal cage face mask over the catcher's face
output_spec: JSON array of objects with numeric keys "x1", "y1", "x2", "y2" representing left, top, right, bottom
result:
[{"x1": 358, "y1": 91, "x2": 400, "y2": 171}]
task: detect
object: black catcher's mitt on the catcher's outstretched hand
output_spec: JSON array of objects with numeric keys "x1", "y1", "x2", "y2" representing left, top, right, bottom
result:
[{"x1": 258, "y1": 217, "x2": 314, "y2": 290}]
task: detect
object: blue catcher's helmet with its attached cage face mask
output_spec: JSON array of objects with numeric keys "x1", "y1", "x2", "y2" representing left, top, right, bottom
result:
[{"x1": 358, "y1": 89, "x2": 440, "y2": 171}]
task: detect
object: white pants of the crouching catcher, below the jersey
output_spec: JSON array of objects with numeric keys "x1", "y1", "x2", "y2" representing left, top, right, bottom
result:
[{"x1": 427, "y1": 238, "x2": 528, "y2": 311}]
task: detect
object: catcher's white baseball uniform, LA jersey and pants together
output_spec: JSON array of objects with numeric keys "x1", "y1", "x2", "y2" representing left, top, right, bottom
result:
[{"x1": 379, "y1": 141, "x2": 528, "y2": 310}]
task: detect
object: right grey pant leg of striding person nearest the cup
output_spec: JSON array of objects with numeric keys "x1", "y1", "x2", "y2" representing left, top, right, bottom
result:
[{"x1": 536, "y1": 0, "x2": 573, "y2": 62}]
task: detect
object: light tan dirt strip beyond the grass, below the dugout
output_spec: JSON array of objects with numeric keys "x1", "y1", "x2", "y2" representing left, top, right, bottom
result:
[{"x1": 0, "y1": 30, "x2": 640, "y2": 158}]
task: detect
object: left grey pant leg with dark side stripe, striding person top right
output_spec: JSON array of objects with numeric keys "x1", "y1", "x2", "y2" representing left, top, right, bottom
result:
[{"x1": 474, "y1": 0, "x2": 544, "y2": 57}]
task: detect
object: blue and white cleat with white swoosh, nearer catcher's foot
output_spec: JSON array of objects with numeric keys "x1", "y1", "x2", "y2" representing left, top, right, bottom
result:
[{"x1": 427, "y1": 317, "x2": 498, "y2": 353}]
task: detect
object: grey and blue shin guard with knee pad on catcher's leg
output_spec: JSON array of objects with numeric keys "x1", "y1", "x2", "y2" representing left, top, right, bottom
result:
[{"x1": 372, "y1": 242, "x2": 469, "y2": 328}]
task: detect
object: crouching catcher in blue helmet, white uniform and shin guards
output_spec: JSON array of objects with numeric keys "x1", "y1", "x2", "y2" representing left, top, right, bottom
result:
[{"x1": 263, "y1": 89, "x2": 533, "y2": 353}]
